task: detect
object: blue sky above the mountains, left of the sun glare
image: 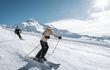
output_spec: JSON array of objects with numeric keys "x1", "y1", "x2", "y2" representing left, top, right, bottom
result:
[{"x1": 0, "y1": 0, "x2": 92, "y2": 24}]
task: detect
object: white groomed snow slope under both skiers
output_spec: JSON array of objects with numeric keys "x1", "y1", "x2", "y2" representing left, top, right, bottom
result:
[{"x1": 0, "y1": 28, "x2": 110, "y2": 70}]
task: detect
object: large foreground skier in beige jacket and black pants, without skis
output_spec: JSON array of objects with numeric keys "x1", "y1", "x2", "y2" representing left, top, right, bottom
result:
[{"x1": 33, "y1": 26, "x2": 62, "y2": 61}]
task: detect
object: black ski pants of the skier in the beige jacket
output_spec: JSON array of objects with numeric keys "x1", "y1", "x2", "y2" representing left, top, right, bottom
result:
[{"x1": 36, "y1": 40, "x2": 49, "y2": 59}]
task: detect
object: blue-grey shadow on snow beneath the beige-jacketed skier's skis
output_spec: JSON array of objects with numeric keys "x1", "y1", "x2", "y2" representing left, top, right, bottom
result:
[{"x1": 18, "y1": 54, "x2": 60, "y2": 70}]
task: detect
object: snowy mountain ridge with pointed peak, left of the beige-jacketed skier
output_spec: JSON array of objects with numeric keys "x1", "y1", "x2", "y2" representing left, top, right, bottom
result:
[{"x1": 1, "y1": 18, "x2": 44, "y2": 33}]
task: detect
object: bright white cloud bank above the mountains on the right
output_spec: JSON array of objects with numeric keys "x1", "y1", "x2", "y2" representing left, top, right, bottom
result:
[{"x1": 48, "y1": 10, "x2": 110, "y2": 36}]
